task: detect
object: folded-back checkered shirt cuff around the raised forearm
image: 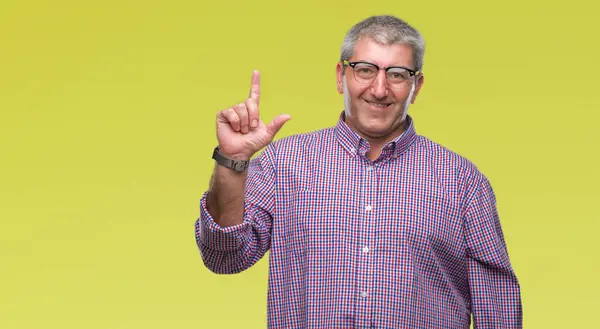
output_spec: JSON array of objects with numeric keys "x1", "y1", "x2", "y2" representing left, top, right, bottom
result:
[{"x1": 195, "y1": 192, "x2": 249, "y2": 251}]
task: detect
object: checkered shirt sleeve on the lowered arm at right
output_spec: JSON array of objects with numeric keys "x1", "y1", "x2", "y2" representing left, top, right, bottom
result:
[{"x1": 465, "y1": 177, "x2": 522, "y2": 329}]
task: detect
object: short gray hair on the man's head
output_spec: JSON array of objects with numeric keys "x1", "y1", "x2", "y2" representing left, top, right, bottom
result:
[{"x1": 340, "y1": 15, "x2": 425, "y2": 71}]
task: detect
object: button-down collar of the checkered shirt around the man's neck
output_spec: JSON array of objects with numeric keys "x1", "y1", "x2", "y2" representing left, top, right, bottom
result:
[{"x1": 335, "y1": 111, "x2": 417, "y2": 157}]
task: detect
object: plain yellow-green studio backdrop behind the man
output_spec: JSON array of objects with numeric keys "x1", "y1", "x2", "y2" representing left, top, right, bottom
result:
[{"x1": 0, "y1": 0, "x2": 600, "y2": 329}]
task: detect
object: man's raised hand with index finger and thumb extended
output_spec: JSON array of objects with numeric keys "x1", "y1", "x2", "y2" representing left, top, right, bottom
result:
[{"x1": 217, "y1": 71, "x2": 291, "y2": 160}]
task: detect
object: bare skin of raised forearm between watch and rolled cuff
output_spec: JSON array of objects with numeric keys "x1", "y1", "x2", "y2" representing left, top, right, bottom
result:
[{"x1": 206, "y1": 164, "x2": 248, "y2": 227}]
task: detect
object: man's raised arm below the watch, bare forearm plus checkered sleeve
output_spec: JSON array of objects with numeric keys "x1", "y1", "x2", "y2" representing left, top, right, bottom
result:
[{"x1": 196, "y1": 150, "x2": 274, "y2": 274}]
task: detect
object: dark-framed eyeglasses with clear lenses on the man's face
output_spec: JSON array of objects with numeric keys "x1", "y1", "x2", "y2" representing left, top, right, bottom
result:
[{"x1": 342, "y1": 60, "x2": 421, "y2": 89}]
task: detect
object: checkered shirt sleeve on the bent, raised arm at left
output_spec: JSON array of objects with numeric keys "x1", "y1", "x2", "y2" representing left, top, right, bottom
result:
[{"x1": 195, "y1": 147, "x2": 275, "y2": 274}]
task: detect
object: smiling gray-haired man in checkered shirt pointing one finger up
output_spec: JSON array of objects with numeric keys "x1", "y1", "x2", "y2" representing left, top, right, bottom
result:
[{"x1": 196, "y1": 16, "x2": 522, "y2": 329}]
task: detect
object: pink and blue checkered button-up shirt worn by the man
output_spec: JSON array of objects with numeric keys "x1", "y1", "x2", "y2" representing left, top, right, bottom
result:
[{"x1": 195, "y1": 114, "x2": 522, "y2": 329}]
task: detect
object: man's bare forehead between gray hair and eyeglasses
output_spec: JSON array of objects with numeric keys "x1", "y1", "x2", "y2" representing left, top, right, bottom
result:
[{"x1": 350, "y1": 37, "x2": 413, "y2": 67}]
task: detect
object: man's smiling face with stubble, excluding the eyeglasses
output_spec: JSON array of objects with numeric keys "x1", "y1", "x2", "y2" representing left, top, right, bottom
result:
[{"x1": 336, "y1": 38, "x2": 423, "y2": 140}]
